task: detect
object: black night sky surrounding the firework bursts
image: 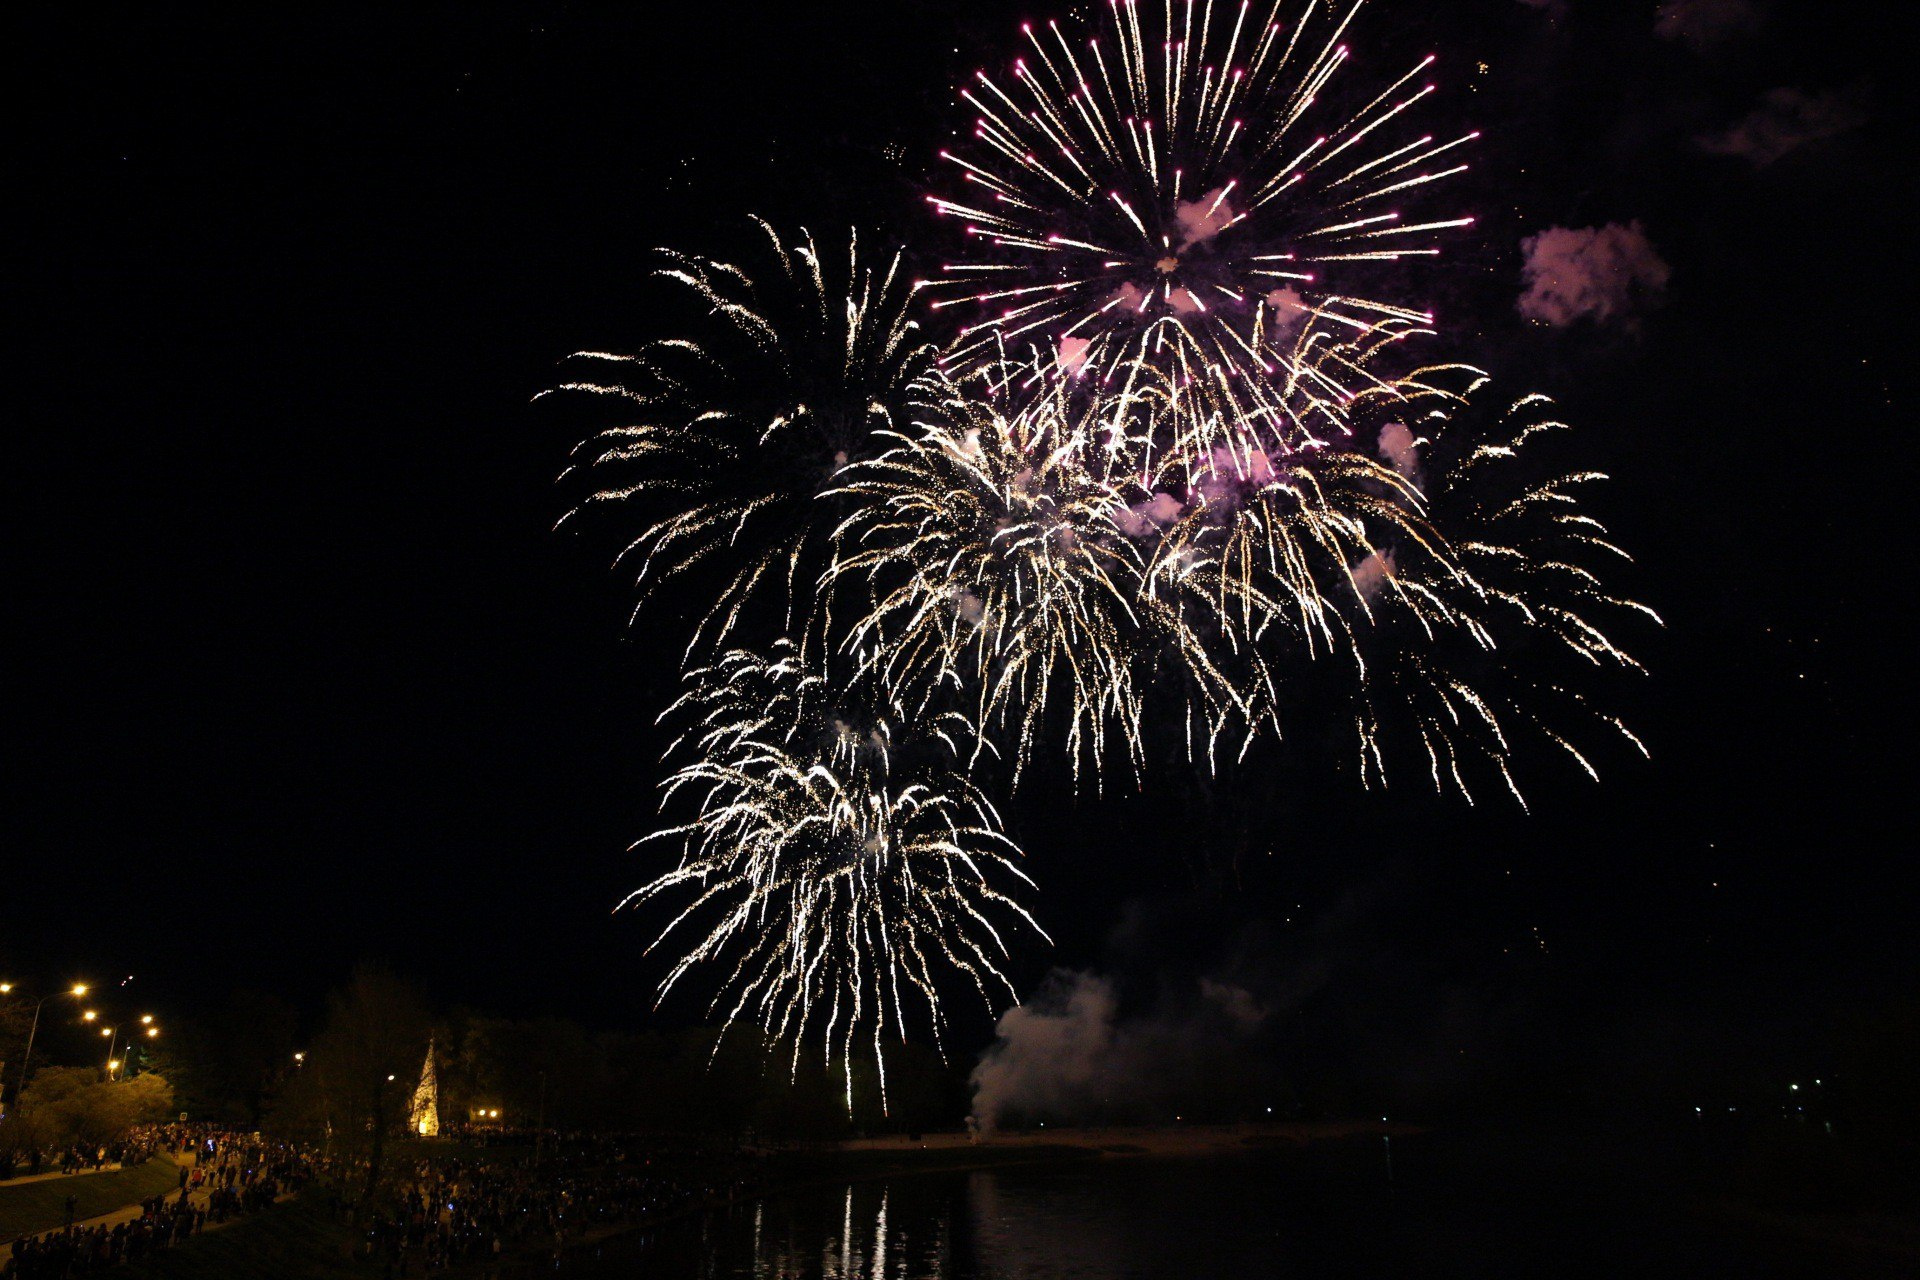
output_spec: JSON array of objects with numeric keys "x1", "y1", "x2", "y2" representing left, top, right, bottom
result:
[{"x1": 0, "y1": 0, "x2": 1920, "y2": 1105}]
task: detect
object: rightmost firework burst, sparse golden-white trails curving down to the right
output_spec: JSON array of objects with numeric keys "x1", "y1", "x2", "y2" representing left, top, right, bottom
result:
[{"x1": 1354, "y1": 365, "x2": 1661, "y2": 806}]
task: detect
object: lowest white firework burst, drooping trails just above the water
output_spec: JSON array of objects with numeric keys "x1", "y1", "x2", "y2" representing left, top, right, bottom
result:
[{"x1": 622, "y1": 643, "x2": 1044, "y2": 1109}]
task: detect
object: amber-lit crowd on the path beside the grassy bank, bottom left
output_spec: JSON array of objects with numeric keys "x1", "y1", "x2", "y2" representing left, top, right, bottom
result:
[{"x1": 0, "y1": 1125, "x2": 315, "y2": 1280}]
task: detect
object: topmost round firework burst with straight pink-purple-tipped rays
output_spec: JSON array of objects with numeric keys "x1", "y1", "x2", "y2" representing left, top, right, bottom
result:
[{"x1": 927, "y1": 0, "x2": 1478, "y2": 451}]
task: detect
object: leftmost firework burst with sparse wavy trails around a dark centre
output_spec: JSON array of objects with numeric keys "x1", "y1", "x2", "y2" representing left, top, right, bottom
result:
[{"x1": 555, "y1": 223, "x2": 927, "y2": 652}]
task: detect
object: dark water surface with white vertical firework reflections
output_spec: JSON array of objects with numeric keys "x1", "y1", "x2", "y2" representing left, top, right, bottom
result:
[{"x1": 566, "y1": 1140, "x2": 1864, "y2": 1280}]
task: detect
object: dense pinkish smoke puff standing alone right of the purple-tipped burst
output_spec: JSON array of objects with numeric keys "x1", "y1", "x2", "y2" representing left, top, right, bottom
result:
[{"x1": 1519, "y1": 221, "x2": 1672, "y2": 328}]
